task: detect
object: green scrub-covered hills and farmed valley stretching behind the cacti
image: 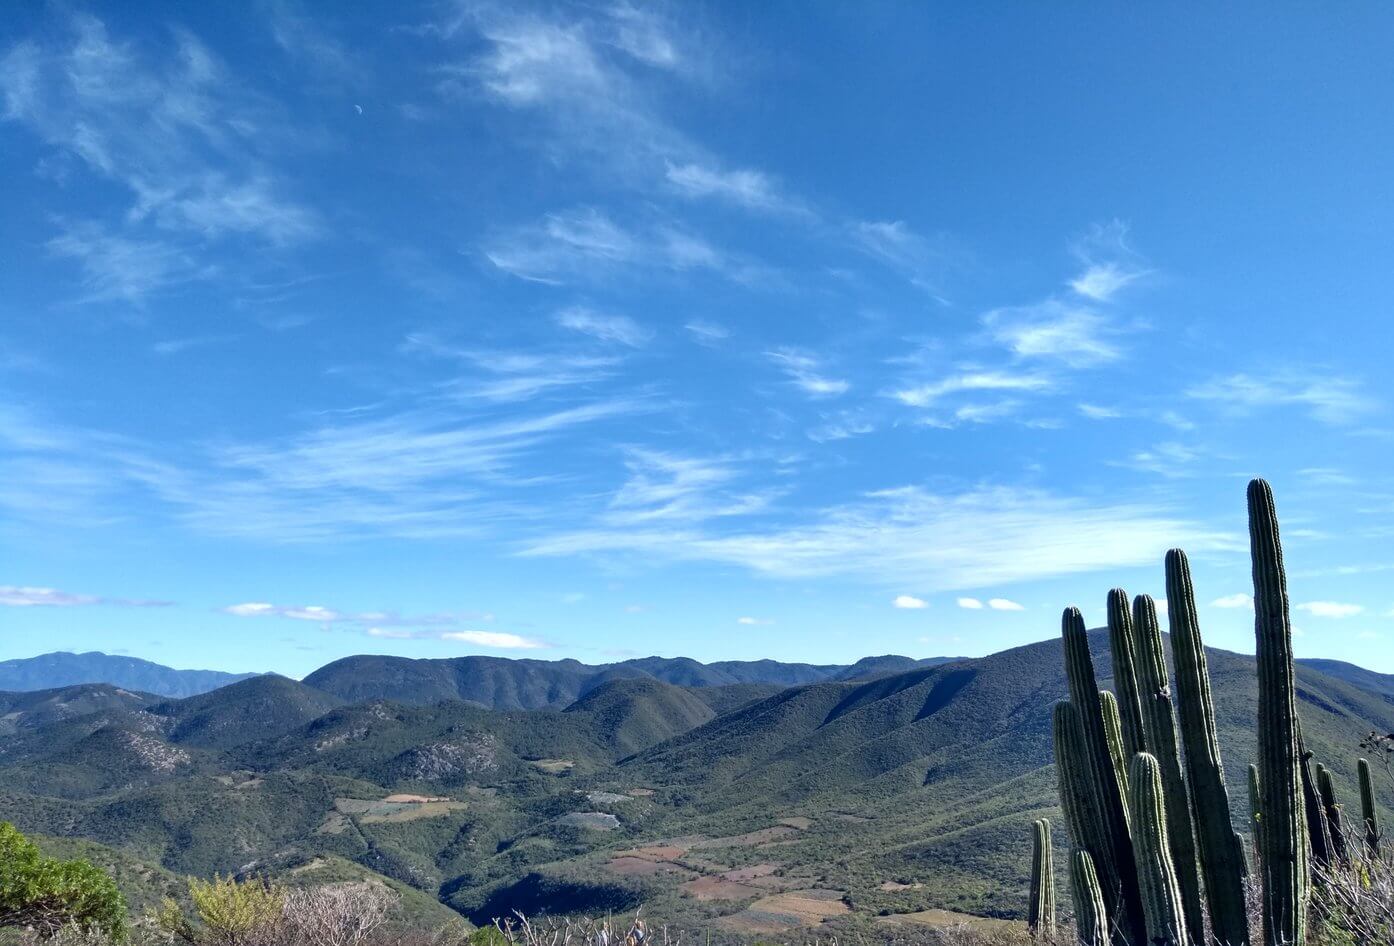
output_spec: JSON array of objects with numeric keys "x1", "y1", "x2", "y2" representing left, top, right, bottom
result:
[{"x1": 0, "y1": 633, "x2": 1394, "y2": 932}]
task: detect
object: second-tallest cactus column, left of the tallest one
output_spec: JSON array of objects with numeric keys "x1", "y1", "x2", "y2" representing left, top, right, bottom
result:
[{"x1": 1167, "y1": 549, "x2": 1257, "y2": 946}]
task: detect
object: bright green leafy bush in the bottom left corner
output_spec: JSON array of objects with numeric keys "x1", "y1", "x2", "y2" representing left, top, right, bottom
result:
[{"x1": 0, "y1": 822, "x2": 127, "y2": 940}]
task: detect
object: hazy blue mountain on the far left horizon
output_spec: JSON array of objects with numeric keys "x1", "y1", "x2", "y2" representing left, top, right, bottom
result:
[{"x1": 0, "y1": 651, "x2": 256, "y2": 697}]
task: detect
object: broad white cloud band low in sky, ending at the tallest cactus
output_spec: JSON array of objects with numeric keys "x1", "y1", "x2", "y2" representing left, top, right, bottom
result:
[{"x1": 523, "y1": 486, "x2": 1238, "y2": 591}]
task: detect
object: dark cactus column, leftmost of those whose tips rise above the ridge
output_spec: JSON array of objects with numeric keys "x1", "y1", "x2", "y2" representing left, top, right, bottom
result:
[{"x1": 1057, "y1": 607, "x2": 1146, "y2": 943}]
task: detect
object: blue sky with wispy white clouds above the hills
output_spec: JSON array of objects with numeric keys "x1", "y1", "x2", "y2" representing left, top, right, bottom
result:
[{"x1": 0, "y1": 0, "x2": 1394, "y2": 676}]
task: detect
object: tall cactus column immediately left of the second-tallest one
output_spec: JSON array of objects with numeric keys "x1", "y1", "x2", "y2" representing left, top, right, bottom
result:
[{"x1": 1132, "y1": 595, "x2": 1204, "y2": 943}]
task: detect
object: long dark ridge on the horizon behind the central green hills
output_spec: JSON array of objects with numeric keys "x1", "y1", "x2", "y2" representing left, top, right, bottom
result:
[{"x1": 305, "y1": 656, "x2": 956, "y2": 709}]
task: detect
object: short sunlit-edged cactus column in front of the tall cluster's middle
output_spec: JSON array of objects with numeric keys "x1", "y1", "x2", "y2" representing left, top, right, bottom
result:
[{"x1": 1128, "y1": 752, "x2": 1190, "y2": 946}]
